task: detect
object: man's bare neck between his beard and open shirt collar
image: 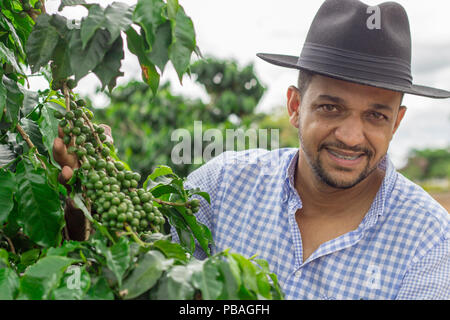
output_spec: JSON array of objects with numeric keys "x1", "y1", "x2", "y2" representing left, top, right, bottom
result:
[{"x1": 295, "y1": 151, "x2": 385, "y2": 218}]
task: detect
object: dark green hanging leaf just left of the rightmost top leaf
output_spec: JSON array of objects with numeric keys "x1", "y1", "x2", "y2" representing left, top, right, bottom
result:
[{"x1": 148, "y1": 21, "x2": 172, "y2": 73}]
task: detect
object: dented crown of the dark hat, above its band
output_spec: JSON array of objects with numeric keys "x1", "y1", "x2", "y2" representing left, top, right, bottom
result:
[{"x1": 306, "y1": 0, "x2": 411, "y2": 64}]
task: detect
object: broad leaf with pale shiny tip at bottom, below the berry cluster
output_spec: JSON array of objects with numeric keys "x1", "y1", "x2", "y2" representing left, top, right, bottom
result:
[{"x1": 121, "y1": 250, "x2": 174, "y2": 299}]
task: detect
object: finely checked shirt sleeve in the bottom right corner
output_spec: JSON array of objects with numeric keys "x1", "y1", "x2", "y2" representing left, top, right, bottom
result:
[{"x1": 397, "y1": 237, "x2": 450, "y2": 300}]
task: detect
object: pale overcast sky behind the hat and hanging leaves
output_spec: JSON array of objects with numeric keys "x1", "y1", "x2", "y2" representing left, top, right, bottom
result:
[{"x1": 34, "y1": 0, "x2": 450, "y2": 167}]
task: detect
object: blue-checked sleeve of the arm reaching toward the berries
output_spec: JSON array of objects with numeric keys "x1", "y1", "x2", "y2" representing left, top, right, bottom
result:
[{"x1": 170, "y1": 152, "x2": 228, "y2": 260}]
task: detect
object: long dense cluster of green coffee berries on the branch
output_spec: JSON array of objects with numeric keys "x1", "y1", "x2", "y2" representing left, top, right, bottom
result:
[{"x1": 55, "y1": 85, "x2": 166, "y2": 232}]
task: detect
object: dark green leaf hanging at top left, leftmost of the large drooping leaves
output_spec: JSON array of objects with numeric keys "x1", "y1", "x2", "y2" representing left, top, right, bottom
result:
[{"x1": 25, "y1": 14, "x2": 59, "y2": 73}]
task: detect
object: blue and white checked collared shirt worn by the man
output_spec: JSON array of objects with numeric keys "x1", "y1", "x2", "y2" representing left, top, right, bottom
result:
[{"x1": 172, "y1": 148, "x2": 450, "y2": 299}]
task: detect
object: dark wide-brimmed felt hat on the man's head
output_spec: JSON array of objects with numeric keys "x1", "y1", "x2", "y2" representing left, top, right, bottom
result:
[{"x1": 257, "y1": 0, "x2": 450, "y2": 98}]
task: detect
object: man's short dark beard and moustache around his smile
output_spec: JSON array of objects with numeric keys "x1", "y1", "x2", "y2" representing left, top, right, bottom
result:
[{"x1": 299, "y1": 130, "x2": 378, "y2": 189}]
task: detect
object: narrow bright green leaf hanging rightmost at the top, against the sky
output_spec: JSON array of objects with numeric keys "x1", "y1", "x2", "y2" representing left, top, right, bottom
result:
[{"x1": 169, "y1": 6, "x2": 195, "y2": 82}]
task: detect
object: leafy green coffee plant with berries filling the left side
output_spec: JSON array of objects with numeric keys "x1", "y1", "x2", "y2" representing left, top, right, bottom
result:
[{"x1": 0, "y1": 0, "x2": 283, "y2": 300}]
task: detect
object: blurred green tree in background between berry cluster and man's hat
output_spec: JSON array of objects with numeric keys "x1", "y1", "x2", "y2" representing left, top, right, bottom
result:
[{"x1": 95, "y1": 58, "x2": 265, "y2": 176}]
